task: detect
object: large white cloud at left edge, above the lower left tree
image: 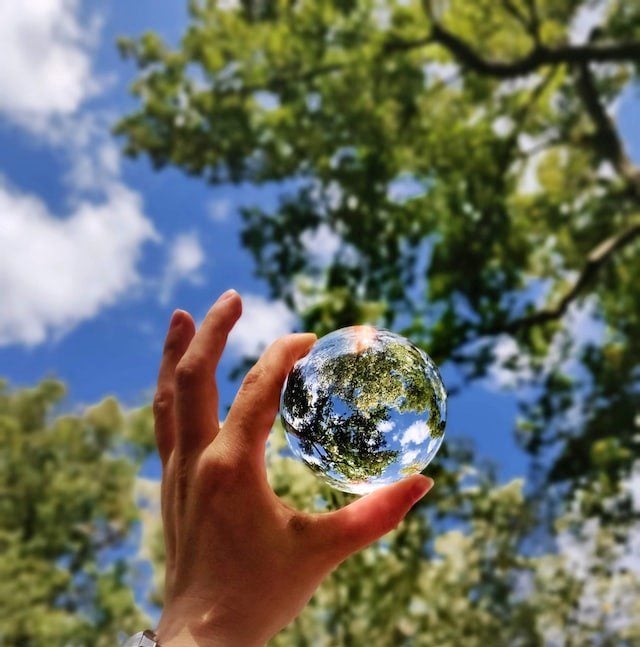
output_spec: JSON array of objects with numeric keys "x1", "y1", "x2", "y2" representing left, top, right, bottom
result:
[{"x1": 0, "y1": 178, "x2": 155, "y2": 345}]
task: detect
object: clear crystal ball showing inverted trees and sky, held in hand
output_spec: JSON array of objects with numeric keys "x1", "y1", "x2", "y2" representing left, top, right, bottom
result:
[{"x1": 280, "y1": 326, "x2": 447, "y2": 494}]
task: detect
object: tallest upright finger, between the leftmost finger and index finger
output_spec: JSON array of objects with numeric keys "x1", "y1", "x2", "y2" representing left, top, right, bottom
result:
[{"x1": 176, "y1": 290, "x2": 242, "y2": 453}]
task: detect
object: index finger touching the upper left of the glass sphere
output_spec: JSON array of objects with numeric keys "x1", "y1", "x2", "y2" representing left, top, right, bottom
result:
[{"x1": 221, "y1": 333, "x2": 317, "y2": 465}]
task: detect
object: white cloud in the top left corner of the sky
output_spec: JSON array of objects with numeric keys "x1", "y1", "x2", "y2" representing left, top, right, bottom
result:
[{"x1": 0, "y1": 0, "x2": 103, "y2": 128}]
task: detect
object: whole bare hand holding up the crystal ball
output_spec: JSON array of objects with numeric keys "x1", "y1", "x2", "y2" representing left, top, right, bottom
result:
[{"x1": 154, "y1": 290, "x2": 433, "y2": 647}]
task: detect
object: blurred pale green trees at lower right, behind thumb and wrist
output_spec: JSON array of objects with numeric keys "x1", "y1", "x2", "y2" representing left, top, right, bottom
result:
[{"x1": 139, "y1": 425, "x2": 640, "y2": 647}]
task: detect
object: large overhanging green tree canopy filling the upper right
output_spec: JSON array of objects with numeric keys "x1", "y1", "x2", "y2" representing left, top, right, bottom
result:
[{"x1": 117, "y1": 0, "x2": 640, "y2": 502}]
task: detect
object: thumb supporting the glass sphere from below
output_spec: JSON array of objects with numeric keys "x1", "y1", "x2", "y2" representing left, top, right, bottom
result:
[{"x1": 318, "y1": 474, "x2": 433, "y2": 562}]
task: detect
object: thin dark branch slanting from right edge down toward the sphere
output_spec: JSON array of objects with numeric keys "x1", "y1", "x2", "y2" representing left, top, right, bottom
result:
[{"x1": 481, "y1": 221, "x2": 640, "y2": 335}]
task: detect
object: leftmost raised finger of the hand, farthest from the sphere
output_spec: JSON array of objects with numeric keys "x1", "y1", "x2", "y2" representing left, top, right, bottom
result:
[{"x1": 153, "y1": 310, "x2": 196, "y2": 465}]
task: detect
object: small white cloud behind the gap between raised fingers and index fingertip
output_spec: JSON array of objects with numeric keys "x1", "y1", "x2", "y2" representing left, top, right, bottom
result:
[{"x1": 229, "y1": 294, "x2": 296, "y2": 357}]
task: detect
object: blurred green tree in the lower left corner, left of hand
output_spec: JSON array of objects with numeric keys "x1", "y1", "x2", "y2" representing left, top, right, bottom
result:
[{"x1": 0, "y1": 380, "x2": 153, "y2": 647}]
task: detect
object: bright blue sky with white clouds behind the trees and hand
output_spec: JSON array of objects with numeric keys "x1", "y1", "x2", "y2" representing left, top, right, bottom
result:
[{"x1": 0, "y1": 0, "x2": 640, "y2": 488}]
